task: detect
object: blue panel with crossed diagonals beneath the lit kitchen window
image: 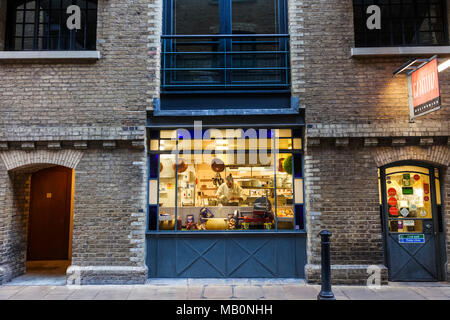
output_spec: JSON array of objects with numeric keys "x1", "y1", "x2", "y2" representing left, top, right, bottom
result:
[{"x1": 147, "y1": 233, "x2": 306, "y2": 278}]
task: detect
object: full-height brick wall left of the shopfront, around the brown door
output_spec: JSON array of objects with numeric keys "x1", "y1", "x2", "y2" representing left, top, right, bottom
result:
[{"x1": 0, "y1": 0, "x2": 149, "y2": 284}]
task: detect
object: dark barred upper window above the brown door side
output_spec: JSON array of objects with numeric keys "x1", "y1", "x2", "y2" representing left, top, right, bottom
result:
[{"x1": 5, "y1": 0, "x2": 97, "y2": 51}]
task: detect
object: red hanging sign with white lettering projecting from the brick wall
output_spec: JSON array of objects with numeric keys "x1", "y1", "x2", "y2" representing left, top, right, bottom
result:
[{"x1": 411, "y1": 58, "x2": 441, "y2": 117}]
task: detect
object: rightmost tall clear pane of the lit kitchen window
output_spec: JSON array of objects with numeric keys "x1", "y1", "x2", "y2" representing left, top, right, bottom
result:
[{"x1": 277, "y1": 154, "x2": 297, "y2": 229}]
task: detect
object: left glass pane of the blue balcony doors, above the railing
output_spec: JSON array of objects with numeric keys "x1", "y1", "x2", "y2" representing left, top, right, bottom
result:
[{"x1": 173, "y1": 0, "x2": 220, "y2": 35}]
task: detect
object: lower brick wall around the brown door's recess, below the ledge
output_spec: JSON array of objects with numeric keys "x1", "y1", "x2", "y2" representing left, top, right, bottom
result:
[{"x1": 0, "y1": 148, "x2": 147, "y2": 284}]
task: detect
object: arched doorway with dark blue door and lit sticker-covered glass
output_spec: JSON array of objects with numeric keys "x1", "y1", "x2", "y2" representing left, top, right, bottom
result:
[{"x1": 380, "y1": 161, "x2": 446, "y2": 281}]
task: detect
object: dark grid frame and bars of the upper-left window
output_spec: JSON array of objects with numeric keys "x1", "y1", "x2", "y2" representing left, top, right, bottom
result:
[{"x1": 5, "y1": 0, "x2": 98, "y2": 51}]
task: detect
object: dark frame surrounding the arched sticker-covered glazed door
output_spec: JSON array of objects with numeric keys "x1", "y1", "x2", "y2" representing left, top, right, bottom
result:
[{"x1": 379, "y1": 160, "x2": 446, "y2": 281}]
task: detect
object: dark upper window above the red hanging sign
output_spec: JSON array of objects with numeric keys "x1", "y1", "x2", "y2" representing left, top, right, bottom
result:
[{"x1": 353, "y1": 0, "x2": 448, "y2": 47}]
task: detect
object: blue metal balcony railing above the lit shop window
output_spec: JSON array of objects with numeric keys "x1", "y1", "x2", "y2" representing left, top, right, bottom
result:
[{"x1": 161, "y1": 34, "x2": 290, "y2": 92}]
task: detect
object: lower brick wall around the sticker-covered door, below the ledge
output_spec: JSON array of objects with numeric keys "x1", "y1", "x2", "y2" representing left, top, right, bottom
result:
[{"x1": 305, "y1": 140, "x2": 450, "y2": 284}]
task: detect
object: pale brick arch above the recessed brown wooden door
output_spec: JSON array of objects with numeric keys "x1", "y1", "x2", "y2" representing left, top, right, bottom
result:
[{"x1": 0, "y1": 150, "x2": 83, "y2": 171}]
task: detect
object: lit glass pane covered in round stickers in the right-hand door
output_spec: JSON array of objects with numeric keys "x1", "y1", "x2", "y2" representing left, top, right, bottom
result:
[{"x1": 386, "y1": 172, "x2": 432, "y2": 219}]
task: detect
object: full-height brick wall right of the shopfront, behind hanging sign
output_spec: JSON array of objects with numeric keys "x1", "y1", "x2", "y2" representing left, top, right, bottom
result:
[{"x1": 298, "y1": 0, "x2": 450, "y2": 284}]
